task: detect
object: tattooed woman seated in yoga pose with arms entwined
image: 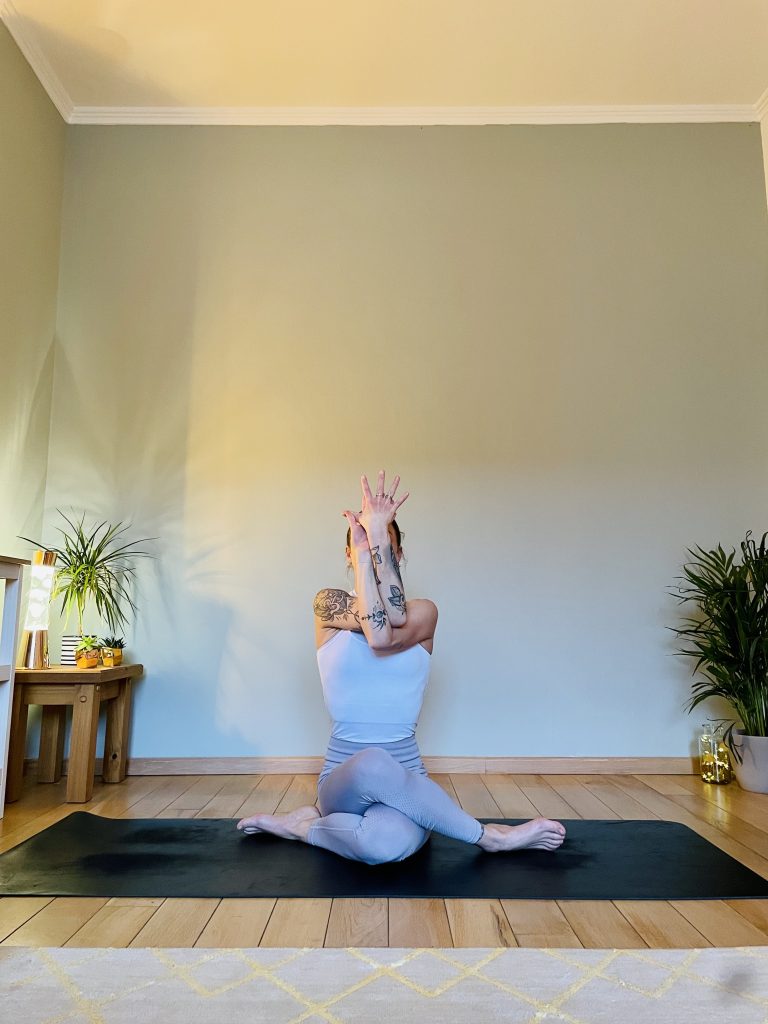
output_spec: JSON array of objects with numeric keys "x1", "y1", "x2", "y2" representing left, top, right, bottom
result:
[{"x1": 238, "y1": 470, "x2": 565, "y2": 864}]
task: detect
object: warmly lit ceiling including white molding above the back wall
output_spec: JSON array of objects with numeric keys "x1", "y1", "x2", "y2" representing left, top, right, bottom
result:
[{"x1": 0, "y1": 0, "x2": 768, "y2": 124}]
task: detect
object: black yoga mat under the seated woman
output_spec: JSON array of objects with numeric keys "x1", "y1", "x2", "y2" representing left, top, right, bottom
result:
[{"x1": 0, "y1": 811, "x2": 768, "y2": 899}]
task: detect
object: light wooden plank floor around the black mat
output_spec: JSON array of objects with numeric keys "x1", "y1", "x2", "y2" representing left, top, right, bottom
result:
[{"x1": 0, "y1": 774, "x2": 768, "y2": 948}]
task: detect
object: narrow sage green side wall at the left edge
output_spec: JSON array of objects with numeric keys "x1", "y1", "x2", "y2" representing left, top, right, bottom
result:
[{"x1": 0, "y1": 24, "x2": 67, "y2": 555}]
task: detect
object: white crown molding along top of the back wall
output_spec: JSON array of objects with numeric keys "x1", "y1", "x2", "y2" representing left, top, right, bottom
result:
[{"x1": 69, "y1": 103, "x2": 760, "y2": 126}]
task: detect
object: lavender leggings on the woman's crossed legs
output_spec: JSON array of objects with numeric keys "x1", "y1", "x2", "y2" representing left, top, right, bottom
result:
[{"x1": 307, "y1": 738, "x2": 482, "y2": 864}]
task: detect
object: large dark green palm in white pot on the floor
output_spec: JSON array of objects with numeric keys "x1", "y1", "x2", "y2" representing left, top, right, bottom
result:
[{"x1": 668, "y1": 530, "x2": 768, "y2": 793}]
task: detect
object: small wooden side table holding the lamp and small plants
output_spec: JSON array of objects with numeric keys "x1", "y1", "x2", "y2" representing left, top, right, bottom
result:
[{"x1": 5, "y1": 665, "x2": 144, "y2": 804}]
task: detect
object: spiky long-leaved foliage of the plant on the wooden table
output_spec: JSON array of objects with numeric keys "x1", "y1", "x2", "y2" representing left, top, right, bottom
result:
[{"x1": 20, "y1": 509, "x2": 155, "y2": 636}]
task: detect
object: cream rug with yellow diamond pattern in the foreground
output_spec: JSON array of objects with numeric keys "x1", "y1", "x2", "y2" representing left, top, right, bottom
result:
[{"x1": 0, "y1": 946, "x2": 768, "y2": 1024}]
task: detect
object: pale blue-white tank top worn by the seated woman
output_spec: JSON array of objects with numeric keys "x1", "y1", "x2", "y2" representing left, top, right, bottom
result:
[{"x1": 317, "y1": 630, "x2": 431, "y2": 743}]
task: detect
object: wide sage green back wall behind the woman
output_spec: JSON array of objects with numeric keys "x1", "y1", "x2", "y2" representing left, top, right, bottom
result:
[{"x1": 47, "y1": 124, "x2": 768, "y2": 757}]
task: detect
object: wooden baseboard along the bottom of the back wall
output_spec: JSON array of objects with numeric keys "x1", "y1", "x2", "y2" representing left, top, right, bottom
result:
[{"x1": 25, "y1": 757, "x2": 697, "y2": 775}]
